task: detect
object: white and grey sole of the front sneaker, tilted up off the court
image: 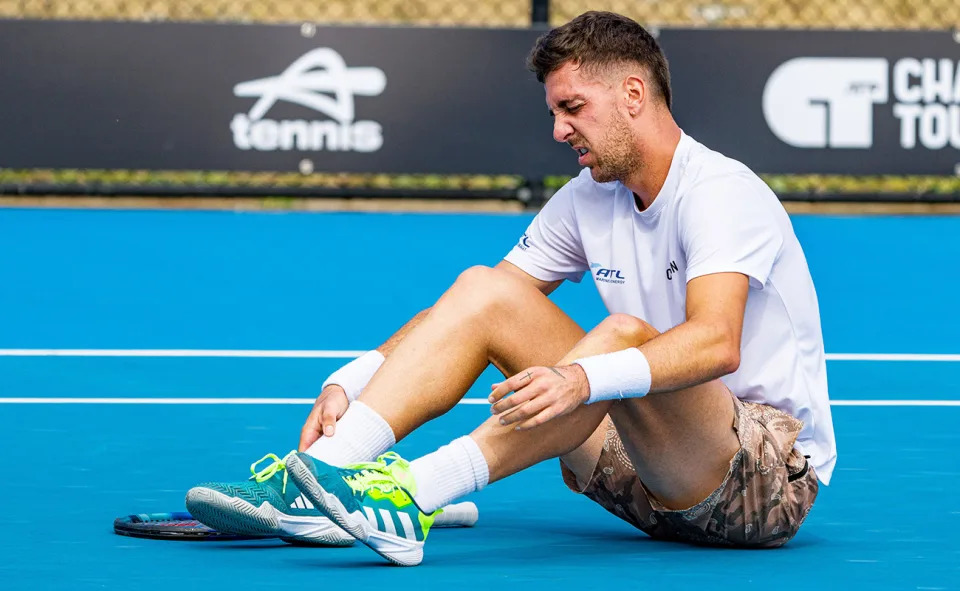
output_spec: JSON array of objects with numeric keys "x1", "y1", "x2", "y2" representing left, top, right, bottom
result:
[{"x1": 286, "y1": 455, "x2": 423, "y2": 566}]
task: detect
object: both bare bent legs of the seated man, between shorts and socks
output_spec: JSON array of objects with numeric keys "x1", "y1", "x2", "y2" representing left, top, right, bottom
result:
[{"x1": 360, "y1": 267, "x2": 739, "y2": 508}]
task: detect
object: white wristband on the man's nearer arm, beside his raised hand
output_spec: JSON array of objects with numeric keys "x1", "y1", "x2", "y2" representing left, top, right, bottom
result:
[{"x1": 574, "y1": 347, "x2": 651, "y2": 404}]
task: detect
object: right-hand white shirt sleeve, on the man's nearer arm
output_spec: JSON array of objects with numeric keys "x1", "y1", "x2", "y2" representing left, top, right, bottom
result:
[{"x1": 678, "y1": 178, "x2": 785, "y2": 289}]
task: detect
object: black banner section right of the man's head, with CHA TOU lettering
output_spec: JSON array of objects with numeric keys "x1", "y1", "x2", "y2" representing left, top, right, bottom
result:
[{"x1": 660, "y1": 30, "x2": 960, "y2": 175}]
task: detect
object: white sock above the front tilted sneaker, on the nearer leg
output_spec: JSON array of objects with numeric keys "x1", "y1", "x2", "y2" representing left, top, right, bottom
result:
[{"x1": 410, "y1": 436, "x2": 490, "y2": 513}]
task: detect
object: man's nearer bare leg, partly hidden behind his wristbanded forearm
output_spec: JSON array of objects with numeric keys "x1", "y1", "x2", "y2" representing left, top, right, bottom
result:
[{"x1": 471, "y1": 315, "x2": 740, "y2": 509}]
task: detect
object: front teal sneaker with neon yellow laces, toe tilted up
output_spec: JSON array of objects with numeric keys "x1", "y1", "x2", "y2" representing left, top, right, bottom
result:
[{"x1": 285, "y1": 452, "x2": 435, "y2": 566}]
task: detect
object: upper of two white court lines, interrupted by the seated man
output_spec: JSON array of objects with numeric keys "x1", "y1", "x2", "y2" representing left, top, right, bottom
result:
[{"x1": 0, "y1": 349, "x2": 960, "y2": 362}]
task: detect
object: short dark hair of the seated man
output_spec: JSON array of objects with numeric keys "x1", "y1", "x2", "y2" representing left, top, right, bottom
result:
[{"x1": 527, "y1": 11, "x2": 671, "y2": 109}]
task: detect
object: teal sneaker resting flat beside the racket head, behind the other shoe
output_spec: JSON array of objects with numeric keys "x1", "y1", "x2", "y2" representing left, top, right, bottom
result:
[{"x1": 187, "y1": 454, "x2": 354, "y2": 546}]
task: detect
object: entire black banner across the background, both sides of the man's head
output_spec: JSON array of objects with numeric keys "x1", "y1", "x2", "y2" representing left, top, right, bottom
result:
[{"x1": 0, "y1": 21, "x2": 960, "y2": 178}]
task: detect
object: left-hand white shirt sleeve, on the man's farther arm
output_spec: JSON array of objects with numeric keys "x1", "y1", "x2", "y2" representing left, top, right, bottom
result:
[{"x1": 504, "y1": 179, "x2": 589, "y2": 283}]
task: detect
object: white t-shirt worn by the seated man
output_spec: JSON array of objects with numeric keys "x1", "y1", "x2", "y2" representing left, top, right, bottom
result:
[{"x1": 506, "y1": 134, "x2": 837, "y2": 484}]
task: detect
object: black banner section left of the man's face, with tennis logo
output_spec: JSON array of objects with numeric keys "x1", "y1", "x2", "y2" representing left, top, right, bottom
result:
[{"x1": 0, "y1": 21, "x2": 576, "y2": 176}]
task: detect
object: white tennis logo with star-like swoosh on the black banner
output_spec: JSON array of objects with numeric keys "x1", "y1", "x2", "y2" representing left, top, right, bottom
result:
[{"x1": 230, "y1": 48, "x2": 387, "y2": 152}]
